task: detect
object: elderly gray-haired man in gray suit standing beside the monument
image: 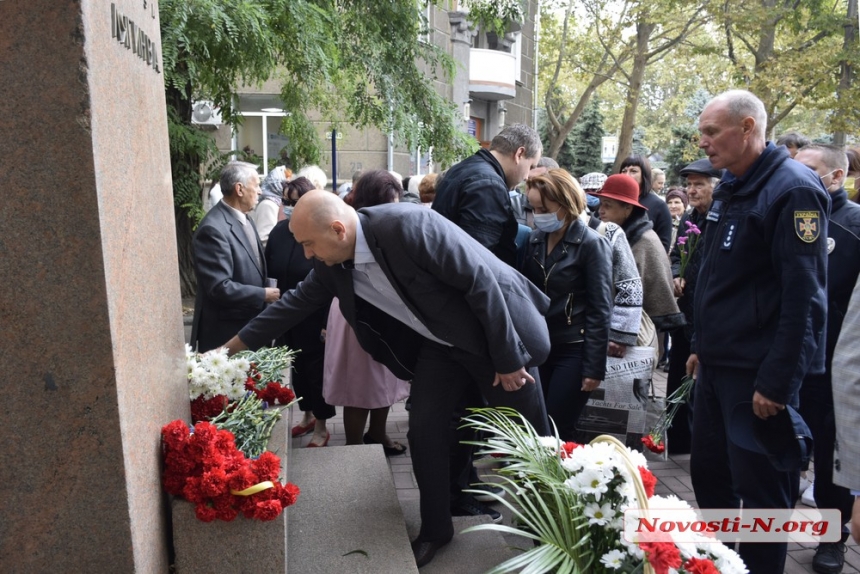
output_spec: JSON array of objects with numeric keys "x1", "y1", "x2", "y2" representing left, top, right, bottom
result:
[{"x1": 191, "y1": 161, "x2": 280, "y2": 352}]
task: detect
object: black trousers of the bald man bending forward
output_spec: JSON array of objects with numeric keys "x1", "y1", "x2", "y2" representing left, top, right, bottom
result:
[{"x1": 407, "y1": 340, "x2": 548, "y2": 542}]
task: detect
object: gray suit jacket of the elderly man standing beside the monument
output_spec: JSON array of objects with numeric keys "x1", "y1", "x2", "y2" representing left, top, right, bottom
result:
[{"x1": 191, "y1": 202, "x2": 266, "y2": 352}]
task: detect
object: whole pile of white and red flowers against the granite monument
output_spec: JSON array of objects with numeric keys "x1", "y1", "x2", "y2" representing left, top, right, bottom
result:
[{"x1": 162, "y1": 345, "x2": 299, "y2": 522}]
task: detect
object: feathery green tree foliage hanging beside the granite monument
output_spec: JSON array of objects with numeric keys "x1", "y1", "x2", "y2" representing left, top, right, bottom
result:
[{"x1": 159, "y1": 0, "x2": 474, "y2": 294}]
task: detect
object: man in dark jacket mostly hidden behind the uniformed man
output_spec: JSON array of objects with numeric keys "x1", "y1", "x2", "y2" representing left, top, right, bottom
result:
[{"x1": 794, "y1": 144, "x2": 860, "y2": 574}]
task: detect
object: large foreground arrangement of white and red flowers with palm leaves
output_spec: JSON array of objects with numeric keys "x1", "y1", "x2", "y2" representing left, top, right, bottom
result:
[{"x1": 464, "y1": 409, "x2": 747, "y2": 574}]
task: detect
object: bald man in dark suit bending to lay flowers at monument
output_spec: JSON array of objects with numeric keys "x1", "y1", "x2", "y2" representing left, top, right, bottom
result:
[{"x1": 227, "y1": 191, "x2": 550, "y2": 567}]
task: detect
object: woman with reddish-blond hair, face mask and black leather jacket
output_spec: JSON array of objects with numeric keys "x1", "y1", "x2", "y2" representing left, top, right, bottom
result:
[{"x1": 521, "y1": 169, "x2": 613, "y2": 441}]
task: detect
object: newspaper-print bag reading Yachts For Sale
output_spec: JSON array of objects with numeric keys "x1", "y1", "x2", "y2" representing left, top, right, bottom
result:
[{"x1": 576, "y1": 347, "x2": 655, "y2": 450}]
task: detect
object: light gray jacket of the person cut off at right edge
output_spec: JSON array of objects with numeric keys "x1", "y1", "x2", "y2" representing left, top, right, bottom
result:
[{"x1": 831, "y1": 281, "x2": 860, "y2": 490}]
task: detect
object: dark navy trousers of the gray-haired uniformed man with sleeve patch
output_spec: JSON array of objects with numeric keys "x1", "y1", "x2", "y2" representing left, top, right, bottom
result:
[{"x1": 690, "y1": 364, "x2": 800, "y2": 574}]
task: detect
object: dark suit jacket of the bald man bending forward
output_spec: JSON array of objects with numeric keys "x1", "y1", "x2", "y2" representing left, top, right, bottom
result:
[{"x1": 239, "y1": 204, "x2": 550, "y2": 380}]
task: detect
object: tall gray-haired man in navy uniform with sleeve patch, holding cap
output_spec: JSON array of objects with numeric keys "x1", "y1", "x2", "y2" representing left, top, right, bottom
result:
[{"x1": 687, "y1": 90, "x2": 830, "y2": 574}]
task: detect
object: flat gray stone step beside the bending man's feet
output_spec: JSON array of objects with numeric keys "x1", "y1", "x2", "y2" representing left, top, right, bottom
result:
[{"x1": 287, "y1": 445, "x2": 423, "y2": 574}]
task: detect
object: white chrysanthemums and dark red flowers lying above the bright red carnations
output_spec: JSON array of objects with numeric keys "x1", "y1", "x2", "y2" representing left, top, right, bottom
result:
[{"x1": 185, "y1": 345, "x2": 295, "y2": 423}]
